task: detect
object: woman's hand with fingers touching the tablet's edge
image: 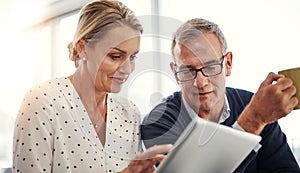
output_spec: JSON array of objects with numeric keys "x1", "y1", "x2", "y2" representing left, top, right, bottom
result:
[{"x1": 121, "y1": 145, "x2": 172, "y2": 173}]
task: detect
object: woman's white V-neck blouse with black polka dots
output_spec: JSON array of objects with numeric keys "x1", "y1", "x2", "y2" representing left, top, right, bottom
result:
[{"x1": 13, "y1": 78, "x2": 141, "y2": 173}]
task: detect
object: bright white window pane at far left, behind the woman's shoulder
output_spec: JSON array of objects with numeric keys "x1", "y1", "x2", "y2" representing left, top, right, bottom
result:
[{"x1": 0, "y1": 22, "x2": 51, "y2": 168}]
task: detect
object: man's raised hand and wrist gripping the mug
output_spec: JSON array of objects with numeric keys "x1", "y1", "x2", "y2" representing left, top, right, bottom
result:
[{"x1": 238, "y1": 72, "x2": 298, "y2": 134}]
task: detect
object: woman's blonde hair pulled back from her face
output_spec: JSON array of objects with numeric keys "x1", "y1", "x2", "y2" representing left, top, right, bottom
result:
[{"x1": 68, "y1": 0, "x2": 143, "y2": 67}]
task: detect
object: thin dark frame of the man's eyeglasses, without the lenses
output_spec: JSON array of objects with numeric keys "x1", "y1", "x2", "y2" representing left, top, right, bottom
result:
[{"x1": 174, "y1": 53, "x2": 228, "y2": 82}]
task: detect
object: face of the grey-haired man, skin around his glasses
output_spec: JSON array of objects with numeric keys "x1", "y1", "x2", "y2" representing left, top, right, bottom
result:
[{"x1": 174, "y1": 33, "x2": 232, "y2": 119}]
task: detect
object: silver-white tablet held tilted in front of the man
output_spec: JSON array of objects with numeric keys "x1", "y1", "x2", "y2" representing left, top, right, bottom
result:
[{"x1": 155, "y1": 117, "x2": 261, "y2": 173}]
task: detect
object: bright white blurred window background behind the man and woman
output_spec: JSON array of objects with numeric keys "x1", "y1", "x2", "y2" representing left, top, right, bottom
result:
[{"x1": 0, "y1": 0, "x2": 300, "y2": 168}]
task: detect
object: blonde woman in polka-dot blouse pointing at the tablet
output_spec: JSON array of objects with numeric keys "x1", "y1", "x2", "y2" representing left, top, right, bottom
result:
[{"x1": 13, "y1": 0, "x2": 170, "y2": 173}]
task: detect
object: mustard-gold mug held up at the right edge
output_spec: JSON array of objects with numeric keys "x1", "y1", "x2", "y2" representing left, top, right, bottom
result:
[{"x1": 278, "y1": 67, "x2": 300, "y2": 109}]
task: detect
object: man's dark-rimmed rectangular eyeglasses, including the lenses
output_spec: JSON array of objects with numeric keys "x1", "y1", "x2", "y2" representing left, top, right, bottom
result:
[{"x1": 175, "y1": 54, "x2": 227, "y2": 82}]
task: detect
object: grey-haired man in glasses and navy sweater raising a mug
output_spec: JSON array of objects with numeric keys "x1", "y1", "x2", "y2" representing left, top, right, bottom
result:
[{"x1": 141, "y1": 19, "x2": 300, "y2": 173}]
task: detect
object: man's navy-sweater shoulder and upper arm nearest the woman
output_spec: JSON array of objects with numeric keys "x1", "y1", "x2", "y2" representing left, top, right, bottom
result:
[{"x1": 141, "y1": 91, "x2": 190, "y2": 148}]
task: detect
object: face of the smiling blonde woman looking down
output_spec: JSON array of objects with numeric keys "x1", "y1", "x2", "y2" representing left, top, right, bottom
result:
[{"x1": 86, "y1": 26, "x2": 140, "y2": 93}]
